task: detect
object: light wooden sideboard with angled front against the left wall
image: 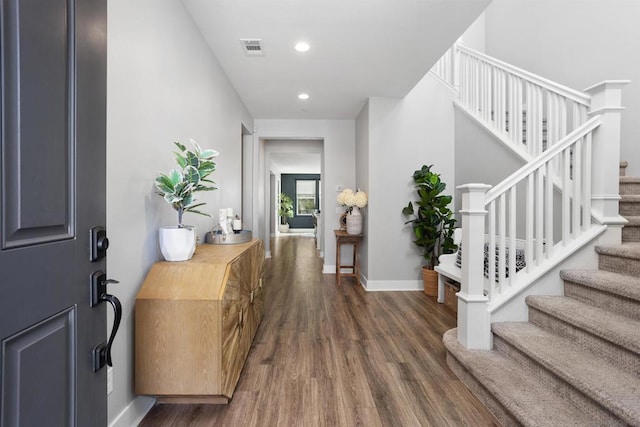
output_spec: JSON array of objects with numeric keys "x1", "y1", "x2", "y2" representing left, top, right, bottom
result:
[{"x1": 135, "y1": 239, "x2": 264, "y2": 403}]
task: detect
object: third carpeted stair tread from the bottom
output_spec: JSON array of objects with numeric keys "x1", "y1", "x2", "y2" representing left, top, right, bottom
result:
[{"x1": 526, "y1": 295, "x2": 640, "y2": 356}]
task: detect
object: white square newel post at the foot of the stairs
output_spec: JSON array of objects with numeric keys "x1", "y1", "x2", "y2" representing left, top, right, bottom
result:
[{"x1": 457, "y1": 184, "x2": 491, "y2": 349}]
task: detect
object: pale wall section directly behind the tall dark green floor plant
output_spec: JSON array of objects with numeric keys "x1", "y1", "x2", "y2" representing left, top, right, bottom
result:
[{"x1": 366, "y1": 74, "x2": 455, "y2": 290}]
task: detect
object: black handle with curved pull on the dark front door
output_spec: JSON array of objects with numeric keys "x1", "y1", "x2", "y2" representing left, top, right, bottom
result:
[{"x1": 91, "y1": 270, "x2": 122, "y2": 372}]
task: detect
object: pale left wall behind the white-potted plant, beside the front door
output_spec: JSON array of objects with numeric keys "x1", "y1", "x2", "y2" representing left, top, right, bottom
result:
[{"x1": 107, "y1": 0, "x2": 253, "y2": 426}]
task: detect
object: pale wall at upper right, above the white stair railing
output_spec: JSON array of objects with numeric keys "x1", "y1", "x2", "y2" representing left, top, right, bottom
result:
[{"x1": 486, "y1": 0, "x2": 640, "y2": 176}]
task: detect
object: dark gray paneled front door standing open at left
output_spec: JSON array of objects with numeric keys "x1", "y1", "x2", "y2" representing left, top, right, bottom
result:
[{"x1": 0, "y1": 0, "x2": 107, "y2": 427}]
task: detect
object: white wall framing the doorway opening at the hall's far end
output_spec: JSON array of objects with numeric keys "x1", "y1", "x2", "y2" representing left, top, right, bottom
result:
[{"x1": 255, "y1": 120, "x2": 355, "y2": 273}]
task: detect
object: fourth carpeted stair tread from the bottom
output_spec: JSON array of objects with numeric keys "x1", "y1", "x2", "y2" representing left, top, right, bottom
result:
[{"x1": 560, "y1": 270, "x2": 640, "y2": 304}]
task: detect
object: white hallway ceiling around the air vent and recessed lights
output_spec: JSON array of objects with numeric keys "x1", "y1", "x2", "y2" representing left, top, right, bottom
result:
[{"x1": 183, "y1": 0, "x2": 491, "y2": 119}]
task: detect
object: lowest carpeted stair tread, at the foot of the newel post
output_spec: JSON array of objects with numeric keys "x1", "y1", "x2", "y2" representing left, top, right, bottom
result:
[{"x1": 443, "y1": 329, "x2": 593, "y2": 426}]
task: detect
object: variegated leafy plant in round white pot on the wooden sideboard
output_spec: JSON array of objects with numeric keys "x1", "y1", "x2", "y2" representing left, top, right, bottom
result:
[{"x1": 155, "y1": 139, "x2": 218, "y2": 261}]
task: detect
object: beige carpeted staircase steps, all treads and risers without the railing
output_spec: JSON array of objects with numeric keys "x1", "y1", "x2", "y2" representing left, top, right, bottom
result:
[{"x1": 444, "y1": 164, "x2": 640, "y2": 426}]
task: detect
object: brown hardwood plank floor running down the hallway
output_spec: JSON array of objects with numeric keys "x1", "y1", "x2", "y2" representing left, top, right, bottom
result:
[{"x1": 141, "y1": 236, "x2": 498, "y2": 426}]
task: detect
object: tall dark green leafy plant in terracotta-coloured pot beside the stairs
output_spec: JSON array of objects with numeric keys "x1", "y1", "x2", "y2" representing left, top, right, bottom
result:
[{"x1": 402, "y1": 165, "x2": 456, "y2": 296}]
